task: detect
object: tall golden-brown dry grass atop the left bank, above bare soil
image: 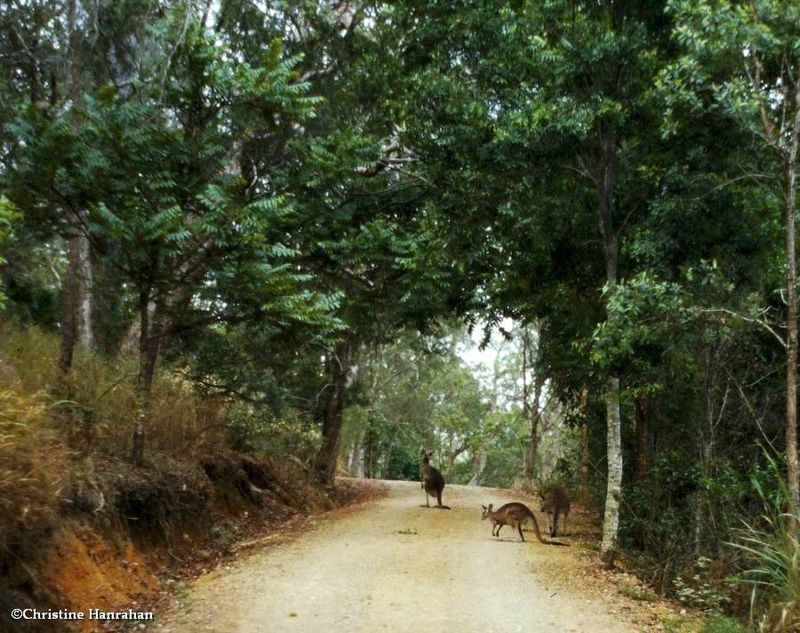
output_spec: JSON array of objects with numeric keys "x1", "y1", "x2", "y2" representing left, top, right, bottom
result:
[{"x1": 0, "y1": 321, "x2": 234, "y2": 576}]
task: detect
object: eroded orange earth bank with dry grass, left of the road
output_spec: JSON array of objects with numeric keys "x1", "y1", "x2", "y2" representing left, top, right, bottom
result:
[{"x1": 0, "y1": 321, "x2": 380, "y2": 630}]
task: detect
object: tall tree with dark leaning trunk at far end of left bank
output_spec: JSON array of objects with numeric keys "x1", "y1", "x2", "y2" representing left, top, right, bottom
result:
[{"x1": 253, "y1": 2, "x2": 466, "y2": 485}]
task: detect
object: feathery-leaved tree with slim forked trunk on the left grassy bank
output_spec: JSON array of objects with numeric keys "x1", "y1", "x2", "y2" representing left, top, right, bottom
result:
[{"x1": 4, "y1": 6, "x2": 335, "y2": 463}]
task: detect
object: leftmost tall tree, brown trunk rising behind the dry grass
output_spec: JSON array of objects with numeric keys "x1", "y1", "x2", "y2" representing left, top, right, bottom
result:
[{"x1": 0, "y1": 0, "x2": 170, "y2": 377}]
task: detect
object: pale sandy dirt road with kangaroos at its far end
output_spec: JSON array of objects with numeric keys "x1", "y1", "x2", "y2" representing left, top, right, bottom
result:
[{"x1": 157, "y1": 482, "x2": 637, "y2": 633}]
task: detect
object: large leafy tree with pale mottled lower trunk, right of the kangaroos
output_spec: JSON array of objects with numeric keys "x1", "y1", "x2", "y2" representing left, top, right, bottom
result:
[{"x1": 390, "y1": 2, "x2": 670, "y2": 564}]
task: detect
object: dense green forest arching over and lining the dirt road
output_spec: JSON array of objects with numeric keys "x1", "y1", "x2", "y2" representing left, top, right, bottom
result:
[{"x1": 0, "y1": 0, "x2": 800, "y2": 631}]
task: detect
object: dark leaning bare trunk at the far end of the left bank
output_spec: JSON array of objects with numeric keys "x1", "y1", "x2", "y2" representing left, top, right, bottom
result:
[{"x1": 316, "y1": 333, "x2": 351, "y2": 486}]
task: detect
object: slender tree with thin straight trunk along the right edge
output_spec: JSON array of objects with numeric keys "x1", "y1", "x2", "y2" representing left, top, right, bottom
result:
[{"x1": 665, "y1": 0, "x2": 800, "y2": 516}]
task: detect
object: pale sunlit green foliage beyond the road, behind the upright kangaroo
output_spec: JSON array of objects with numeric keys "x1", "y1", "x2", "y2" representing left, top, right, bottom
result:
[{"x1": 343, "y1": 332, "x2": 489, "y2": 483}]
